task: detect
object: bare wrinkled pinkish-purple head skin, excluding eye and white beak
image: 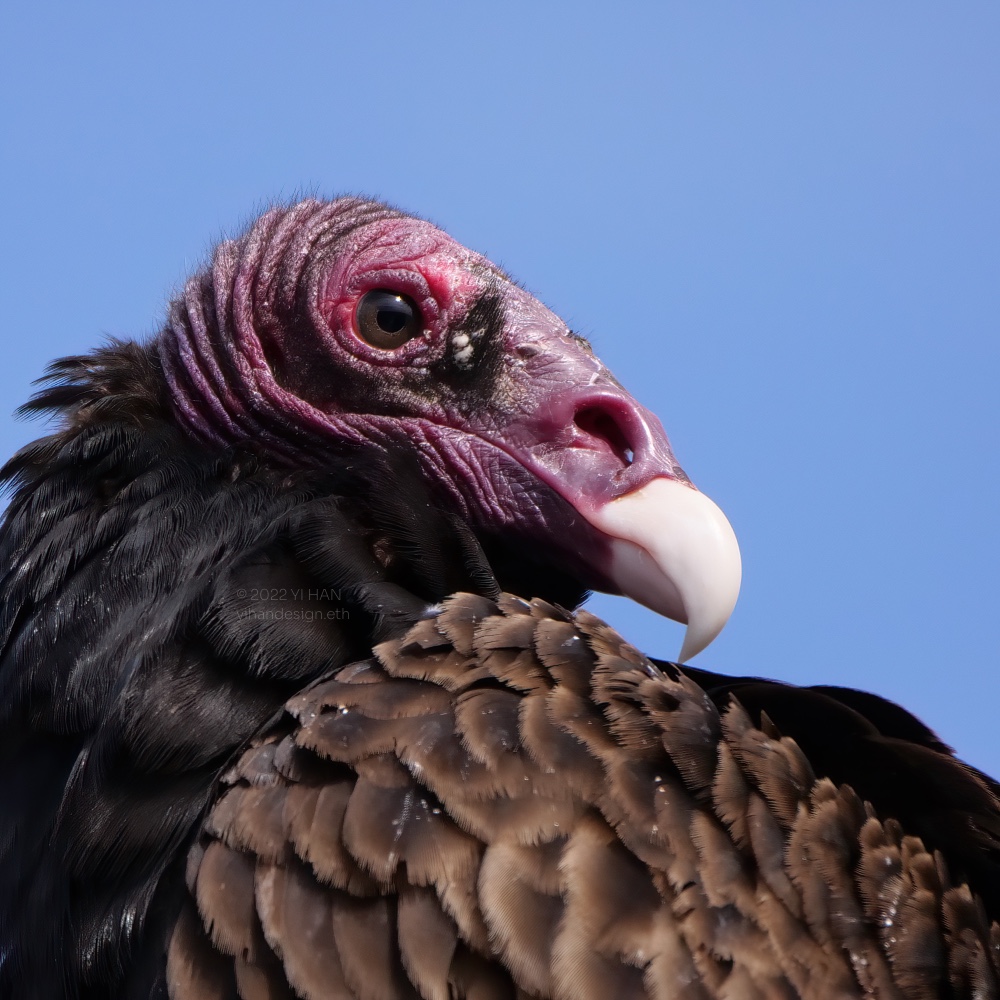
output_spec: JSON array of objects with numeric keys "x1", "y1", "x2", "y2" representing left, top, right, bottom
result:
[{"x1": 160, "y1": 198, "x2": 687, "y2": 590}]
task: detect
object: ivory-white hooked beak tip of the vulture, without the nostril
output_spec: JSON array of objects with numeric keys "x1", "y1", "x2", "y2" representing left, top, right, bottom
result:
[{"x1": 585, "y1": 476, "x2": 742, "y2": 663}]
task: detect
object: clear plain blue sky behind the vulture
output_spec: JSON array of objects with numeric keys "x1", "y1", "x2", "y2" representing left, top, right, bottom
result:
[{"x1": 0, "y1": 0, "x2": 1000, "y2": 774}]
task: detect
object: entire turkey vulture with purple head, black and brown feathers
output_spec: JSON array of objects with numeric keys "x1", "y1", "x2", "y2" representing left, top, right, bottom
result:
[{"x1": 0, "y1": 199, "x2": 1000, "y2": 1000}]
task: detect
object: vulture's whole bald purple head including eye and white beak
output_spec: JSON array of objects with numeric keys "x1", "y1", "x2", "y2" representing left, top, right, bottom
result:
[{"x1": 156, "y1": 198, "x2": 740, "y2": 659}]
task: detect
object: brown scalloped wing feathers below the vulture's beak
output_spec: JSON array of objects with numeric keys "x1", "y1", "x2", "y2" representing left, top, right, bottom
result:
[{"x1": 176, "y1": 595, "x2": 1000, "y2": 1000}]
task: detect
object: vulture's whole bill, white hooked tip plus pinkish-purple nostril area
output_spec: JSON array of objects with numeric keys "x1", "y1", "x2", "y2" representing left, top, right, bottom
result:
[{"x1": 488, "y1": 372, "x2": 742, "y2": 661}]
